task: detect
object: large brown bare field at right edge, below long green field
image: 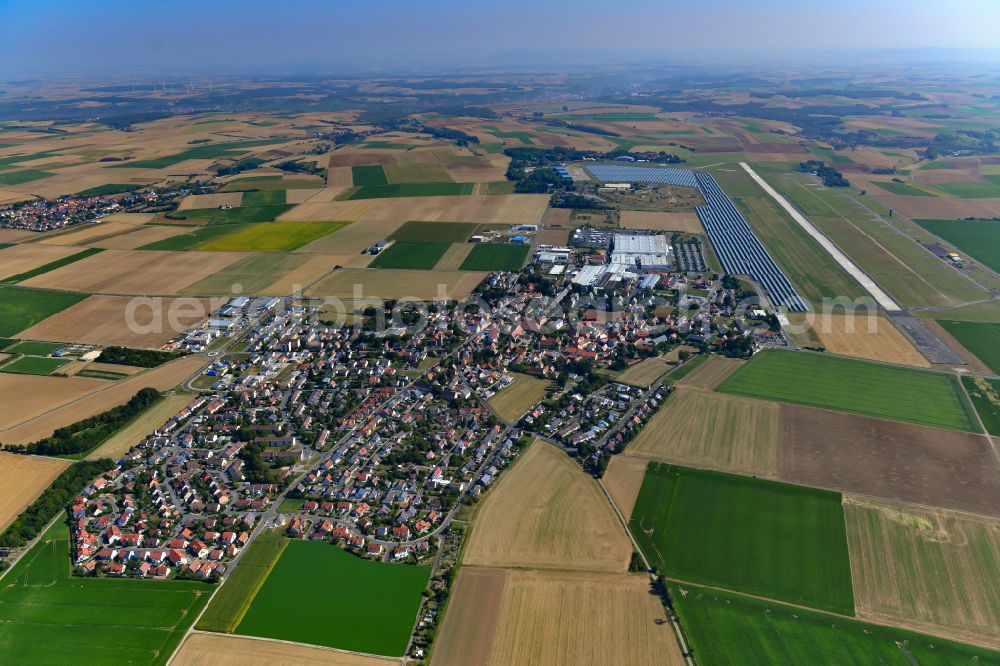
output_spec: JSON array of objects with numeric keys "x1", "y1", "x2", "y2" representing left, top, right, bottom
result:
[{"x1": 778, "y1": 405, "x2": 1000, "y2": 516}]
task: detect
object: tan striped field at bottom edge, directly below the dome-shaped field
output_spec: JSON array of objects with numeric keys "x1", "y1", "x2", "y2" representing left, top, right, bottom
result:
[{"x1": 488, "y1": 571, "x2": 684, "y2": 666}]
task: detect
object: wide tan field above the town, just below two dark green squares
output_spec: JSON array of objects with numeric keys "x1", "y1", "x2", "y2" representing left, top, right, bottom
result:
[{"x1": 305, "y1": 270, "x2": 486, "y2": 301}]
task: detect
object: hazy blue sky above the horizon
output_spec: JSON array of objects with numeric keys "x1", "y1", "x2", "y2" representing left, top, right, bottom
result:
[{"x1": 0, "y1": 0, "x2": 1000, "y2": 79}]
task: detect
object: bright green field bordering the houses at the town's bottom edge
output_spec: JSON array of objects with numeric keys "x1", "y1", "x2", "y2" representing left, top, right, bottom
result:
[{"x1": 236, "y1": 540, "x2": 430, "y2": 657}]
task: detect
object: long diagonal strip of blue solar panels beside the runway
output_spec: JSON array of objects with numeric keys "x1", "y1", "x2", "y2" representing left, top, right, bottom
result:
[{"x1": 694, "y1": 171, "x2": 809, "y2": 312}]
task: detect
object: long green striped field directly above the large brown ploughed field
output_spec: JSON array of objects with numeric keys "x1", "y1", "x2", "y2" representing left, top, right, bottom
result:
[{"x1": 717, "y1": 350, "x2": 977, "y2": 431}]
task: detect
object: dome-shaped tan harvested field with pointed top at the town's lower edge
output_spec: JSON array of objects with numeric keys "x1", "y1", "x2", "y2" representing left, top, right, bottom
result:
[{"x1": 463, "y1": 440, "x2": 632, "y2": 572}]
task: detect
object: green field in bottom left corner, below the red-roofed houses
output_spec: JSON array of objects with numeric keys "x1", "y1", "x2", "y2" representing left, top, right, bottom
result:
[{"x1": 0, "y1": 523, "x2": 213, "y2": 666}]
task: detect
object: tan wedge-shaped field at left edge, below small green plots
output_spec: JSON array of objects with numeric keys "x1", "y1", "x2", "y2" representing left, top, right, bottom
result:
[{"x1": 0, "y1": 372, "x2": 106, "y2": 430}]
